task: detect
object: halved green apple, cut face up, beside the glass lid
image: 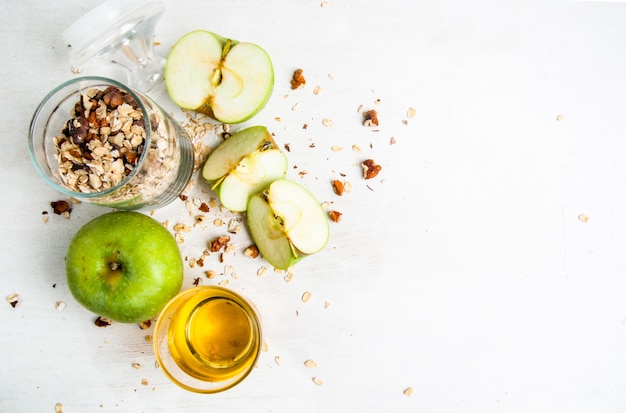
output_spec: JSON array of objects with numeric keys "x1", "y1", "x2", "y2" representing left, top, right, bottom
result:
[{"x1": 165, "y1": 30, "x2": 274, "y2": 123}]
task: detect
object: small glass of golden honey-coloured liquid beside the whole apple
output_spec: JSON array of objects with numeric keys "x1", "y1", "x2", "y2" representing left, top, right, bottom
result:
[{"x1": 153, "y1": 286, "x2": 262, "y2": 393}]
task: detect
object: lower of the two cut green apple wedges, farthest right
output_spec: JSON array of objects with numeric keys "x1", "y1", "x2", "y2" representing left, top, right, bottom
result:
[{"x1": 247, "y1": 179, "x2": 330, "y2": 269}]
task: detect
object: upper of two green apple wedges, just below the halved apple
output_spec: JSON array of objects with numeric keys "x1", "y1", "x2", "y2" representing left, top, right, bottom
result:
[{"x1": 202, "y1": 126, "x2": 288, "y2": 212}]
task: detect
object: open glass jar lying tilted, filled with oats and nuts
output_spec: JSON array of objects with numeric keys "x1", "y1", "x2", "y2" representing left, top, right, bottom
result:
[{"x1": 29, "y1": 76, "x2": 194, "y2": 210}]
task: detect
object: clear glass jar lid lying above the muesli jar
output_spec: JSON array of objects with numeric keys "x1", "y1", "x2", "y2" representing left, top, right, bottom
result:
[{"x1": 62, "y1": 0, "x2": 165, "y2": 92}]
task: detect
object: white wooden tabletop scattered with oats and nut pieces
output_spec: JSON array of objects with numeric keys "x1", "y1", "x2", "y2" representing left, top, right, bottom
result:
[{"x1": 0, "y1": 0, "x2": 626, "y2": 413}]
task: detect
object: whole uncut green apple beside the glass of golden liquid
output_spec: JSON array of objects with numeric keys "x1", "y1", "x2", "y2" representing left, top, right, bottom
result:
[{"x1": 65, "y1": 211, "x2": 183, "y2": 323}]
